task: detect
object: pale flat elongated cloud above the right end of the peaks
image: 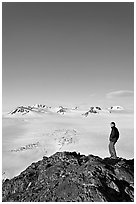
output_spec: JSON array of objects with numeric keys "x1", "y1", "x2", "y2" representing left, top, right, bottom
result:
[{"x1": 106, "y1": 90, "x2": 134, "y2": 99}]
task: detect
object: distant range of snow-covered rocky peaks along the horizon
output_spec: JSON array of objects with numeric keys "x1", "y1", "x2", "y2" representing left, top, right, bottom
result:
[{"x1": 2, "y1": 104, "x2": 124, "y2": 117}]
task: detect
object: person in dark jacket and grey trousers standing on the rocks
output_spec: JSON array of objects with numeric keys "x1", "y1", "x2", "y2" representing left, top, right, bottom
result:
[{"x1": 109, "y1": 122, "x2": 119, "y2": 159}]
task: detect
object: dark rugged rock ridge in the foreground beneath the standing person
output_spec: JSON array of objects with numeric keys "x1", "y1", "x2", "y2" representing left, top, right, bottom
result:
[{"x1": 2, "y1": 152, "x2": 134, "y2": 202}]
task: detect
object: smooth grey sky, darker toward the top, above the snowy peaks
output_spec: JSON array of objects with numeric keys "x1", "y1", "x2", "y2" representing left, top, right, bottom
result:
[{"x1": 2, "y1": 2, "x2": 134, "y2": 111}]
